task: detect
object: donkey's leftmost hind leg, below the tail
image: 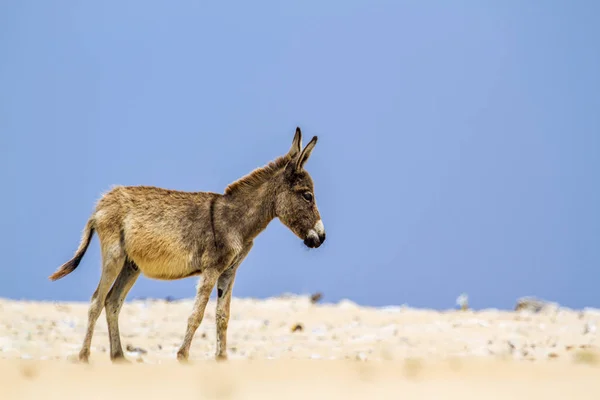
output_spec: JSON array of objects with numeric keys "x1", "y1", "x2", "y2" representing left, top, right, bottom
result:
[{"x1": 79, "y1": 244, "x2": 125, "y2": 363}]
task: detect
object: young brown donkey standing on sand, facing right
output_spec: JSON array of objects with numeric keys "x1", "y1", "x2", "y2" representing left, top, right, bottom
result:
[{"x1": 49, "y1": 127, "x2": 325, "y2": 363}]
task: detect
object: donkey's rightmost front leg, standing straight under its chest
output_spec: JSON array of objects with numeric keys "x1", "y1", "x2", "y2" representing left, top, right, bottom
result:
[{"x1": 215, "y1": 245, "x2": 252, "y2": 361}]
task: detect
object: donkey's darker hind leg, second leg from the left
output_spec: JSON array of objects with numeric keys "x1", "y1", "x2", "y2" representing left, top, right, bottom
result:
[{"x1": 104, "y1": 260, "x2": 140, "y2": 362}]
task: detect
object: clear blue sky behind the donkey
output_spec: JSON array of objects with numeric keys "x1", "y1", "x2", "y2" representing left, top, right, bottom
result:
[{"x1": 0, "y1": 0, "x2": 600, "y2": 308}]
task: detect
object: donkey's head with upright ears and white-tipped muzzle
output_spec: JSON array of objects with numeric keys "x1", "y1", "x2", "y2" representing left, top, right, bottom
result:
[{"x1": 275, "y1": 128, "x2": 325, "y2": 248}]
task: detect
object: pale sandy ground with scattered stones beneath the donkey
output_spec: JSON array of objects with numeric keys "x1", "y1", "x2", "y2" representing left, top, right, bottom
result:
[{"x1": 0, "y1": 297, "x2": 600, "y2": 399}]
